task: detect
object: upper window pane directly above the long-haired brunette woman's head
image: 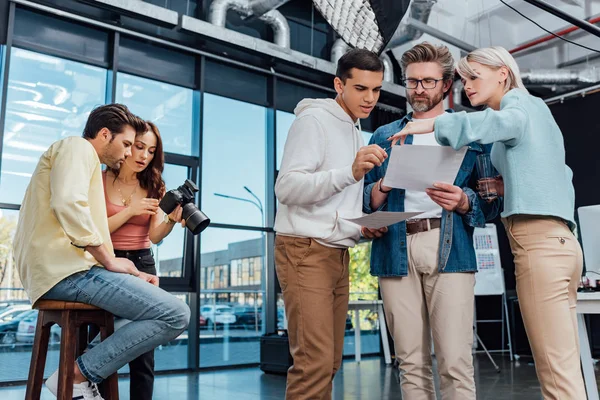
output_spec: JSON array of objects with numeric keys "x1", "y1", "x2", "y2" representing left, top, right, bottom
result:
[{"x1": 116, "y1": 72, "x2": 198, "y2": 155}]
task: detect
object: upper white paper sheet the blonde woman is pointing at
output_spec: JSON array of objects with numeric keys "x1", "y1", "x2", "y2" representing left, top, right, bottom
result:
[{"x1": 383, "y1": 145, "x2": 467, "y2": 192}]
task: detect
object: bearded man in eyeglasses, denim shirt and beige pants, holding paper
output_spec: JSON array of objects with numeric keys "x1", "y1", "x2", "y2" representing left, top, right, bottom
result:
[{"x1": 362, "y1": 43, "x2": 499, "y2": 400}]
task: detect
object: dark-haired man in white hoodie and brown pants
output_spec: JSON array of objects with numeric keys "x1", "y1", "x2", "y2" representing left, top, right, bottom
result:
[{"x1": 275, "y1": 49, "x2": 387, "y2": 400}]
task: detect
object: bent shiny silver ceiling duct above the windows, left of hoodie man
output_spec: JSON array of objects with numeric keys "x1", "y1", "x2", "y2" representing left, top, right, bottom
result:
[{"x1": 208, "y1": 0, "x2": 290, "y2": 49}]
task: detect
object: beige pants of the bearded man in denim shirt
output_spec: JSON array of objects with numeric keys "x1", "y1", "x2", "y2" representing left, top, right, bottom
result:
[{"x1": 379, "y1": 229, "x2": 475, "y2": 400}]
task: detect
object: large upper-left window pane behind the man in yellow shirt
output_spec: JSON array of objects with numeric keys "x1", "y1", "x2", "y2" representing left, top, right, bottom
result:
[{"x1": 0, "y1": 48, "x2": 106, "y2": 204}]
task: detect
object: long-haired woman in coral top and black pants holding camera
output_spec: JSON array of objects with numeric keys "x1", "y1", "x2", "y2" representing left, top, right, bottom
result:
[{"x1": 103, "y1": 122, "x2": 185, "y2": 400}]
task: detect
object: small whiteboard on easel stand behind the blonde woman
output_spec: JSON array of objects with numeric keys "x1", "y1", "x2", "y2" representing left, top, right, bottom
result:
[{"x1": 473, "y1": 224, "x2": 504, "y2": 296}]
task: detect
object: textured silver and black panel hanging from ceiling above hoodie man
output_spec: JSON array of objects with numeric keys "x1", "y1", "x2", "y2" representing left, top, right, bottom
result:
[{"x1": 313, "y1": 0, "x2": 410, "y2": 54}]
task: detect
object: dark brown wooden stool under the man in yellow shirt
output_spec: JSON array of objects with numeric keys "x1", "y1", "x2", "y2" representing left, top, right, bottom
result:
[{"x1": 25, "y1": 300, "x2": 119, "y2": 400}]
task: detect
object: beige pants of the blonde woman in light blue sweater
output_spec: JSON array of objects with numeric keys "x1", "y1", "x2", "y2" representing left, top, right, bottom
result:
[{"x1": 502, "y1": 215, "x2": 586, "y2": 400}]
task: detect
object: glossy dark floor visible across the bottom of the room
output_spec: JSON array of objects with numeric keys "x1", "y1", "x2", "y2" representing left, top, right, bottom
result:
[{"x1": 0, "y1": 355, "x2": 592, "y2": 400}]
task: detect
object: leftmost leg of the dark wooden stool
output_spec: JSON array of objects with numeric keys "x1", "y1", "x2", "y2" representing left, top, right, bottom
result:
[{"x1": 25, "y1": 311, "x2": 51, "y2": 400}]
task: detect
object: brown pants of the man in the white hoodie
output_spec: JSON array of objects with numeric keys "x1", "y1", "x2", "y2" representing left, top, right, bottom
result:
[{"x1": 275, "y1": 235, "x2": 349, "y2": 400}]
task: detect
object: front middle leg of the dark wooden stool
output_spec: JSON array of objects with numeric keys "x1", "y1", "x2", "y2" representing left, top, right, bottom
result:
[{"x1": 57, "y1": 310, "x2": 77, "y2": 400}]
